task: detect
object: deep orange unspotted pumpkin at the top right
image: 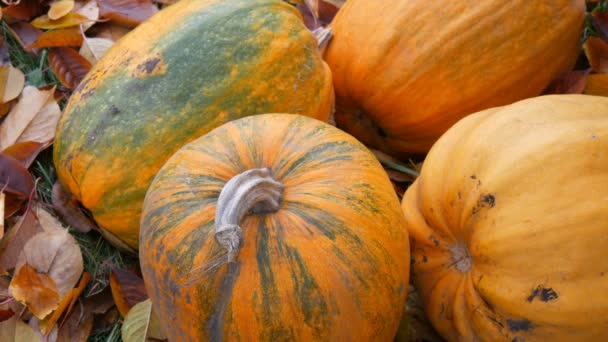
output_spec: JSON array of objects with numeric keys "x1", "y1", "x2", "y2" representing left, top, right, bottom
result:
[{"x1": 325, "y1": 0, "x2": 585, "y2": 158}]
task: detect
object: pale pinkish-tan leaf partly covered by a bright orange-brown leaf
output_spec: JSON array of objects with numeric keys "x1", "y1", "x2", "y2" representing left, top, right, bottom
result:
[{"x1": 17, "y1": 229, "x2": 84, "y2": 298}]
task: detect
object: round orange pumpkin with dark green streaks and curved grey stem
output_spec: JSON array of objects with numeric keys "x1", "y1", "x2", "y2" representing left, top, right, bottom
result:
[{"x1": 139, "y1": 114, "x2": 409, "y2": 341}]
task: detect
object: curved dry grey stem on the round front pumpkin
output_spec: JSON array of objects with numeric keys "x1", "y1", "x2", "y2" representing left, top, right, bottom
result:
[{"x1": 215, "y1": 167, "x2": 285, "y2": 262}]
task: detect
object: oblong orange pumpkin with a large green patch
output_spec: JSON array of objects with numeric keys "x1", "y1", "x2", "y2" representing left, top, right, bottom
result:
[{"x1": 54, "y1": 0, "x2": 333, "y2": 249}]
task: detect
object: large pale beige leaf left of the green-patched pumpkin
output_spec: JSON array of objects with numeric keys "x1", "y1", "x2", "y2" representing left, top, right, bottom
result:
[{"x1": 0, "y1": 86, "x2": 61, "y2": 150}]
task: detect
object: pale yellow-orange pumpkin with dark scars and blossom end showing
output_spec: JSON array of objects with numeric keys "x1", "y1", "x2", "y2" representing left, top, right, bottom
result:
[{"x1": 402, "y1": 95, "x2": 608, "y2": 341}]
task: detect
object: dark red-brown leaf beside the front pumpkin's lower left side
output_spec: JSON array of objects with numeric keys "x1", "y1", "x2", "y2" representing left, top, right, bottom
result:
[{"x1": 110, "y1": 269, "x2": 148, "y2": 317}]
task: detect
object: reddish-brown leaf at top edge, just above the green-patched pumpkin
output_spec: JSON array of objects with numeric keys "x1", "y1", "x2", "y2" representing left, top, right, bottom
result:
[{"x1": 98, "y1": 0, "x2": 158, "y2": 27}]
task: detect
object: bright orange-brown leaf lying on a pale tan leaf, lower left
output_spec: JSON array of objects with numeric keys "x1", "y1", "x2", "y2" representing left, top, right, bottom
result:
[{"x1": 9, "y1": 263, "x2": 60, "y2": 320}]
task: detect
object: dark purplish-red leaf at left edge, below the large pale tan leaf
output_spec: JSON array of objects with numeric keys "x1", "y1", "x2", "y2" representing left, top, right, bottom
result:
[{"x1": 0, "y1": 153, "x2": 34, "y2": 198}]
